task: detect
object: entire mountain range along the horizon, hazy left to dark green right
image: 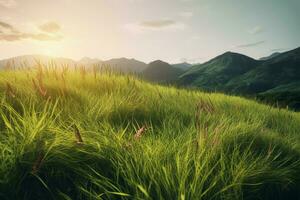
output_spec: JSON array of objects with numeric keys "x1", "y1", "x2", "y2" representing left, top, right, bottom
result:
[{"x1": 0, "y1": 48, "x2": 300, "y2": 110}]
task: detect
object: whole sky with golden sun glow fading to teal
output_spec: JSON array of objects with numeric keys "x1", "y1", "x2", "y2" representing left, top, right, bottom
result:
[{"x1": 0, "y1": 0, "x2": 300, "y2": 63}]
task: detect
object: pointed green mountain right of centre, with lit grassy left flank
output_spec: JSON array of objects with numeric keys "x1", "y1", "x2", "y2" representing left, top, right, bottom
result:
[{"x1": 179, "y1": 52, "x2": 260, "y2": 90}]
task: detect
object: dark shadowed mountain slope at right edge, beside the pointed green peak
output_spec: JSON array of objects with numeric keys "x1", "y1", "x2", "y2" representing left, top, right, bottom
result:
[{"x1": 226, "y1": 48, "x2": 300, "y2": 94}]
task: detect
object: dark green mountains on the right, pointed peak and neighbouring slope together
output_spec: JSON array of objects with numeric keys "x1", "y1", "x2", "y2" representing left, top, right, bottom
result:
[{"x1": 178, "y1": 48, "x2": 300, "y2": 109}]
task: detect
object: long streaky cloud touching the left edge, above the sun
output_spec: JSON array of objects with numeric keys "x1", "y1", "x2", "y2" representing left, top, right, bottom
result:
[{"x1": 0, "y1": 21, "x2": 63, "y2": 42}]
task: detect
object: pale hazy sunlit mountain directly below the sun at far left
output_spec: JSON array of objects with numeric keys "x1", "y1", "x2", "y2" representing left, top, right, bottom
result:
[{"x1": 0, "y1": 55, "x2": 76, "y2": 69}]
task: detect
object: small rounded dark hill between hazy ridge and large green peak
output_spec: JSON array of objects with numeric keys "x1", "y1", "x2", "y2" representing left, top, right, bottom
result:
[{"x1": 141, "y1": 60, "x2": 183, "y2": 82}]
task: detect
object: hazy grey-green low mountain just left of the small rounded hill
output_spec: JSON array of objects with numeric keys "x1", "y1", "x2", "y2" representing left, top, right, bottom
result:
[{"x1": 102, "y1": 58, "x2": 148, "y2": 73}]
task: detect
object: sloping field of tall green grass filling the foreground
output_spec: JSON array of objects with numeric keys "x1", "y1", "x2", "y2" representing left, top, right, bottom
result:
[{"x1": 0, "y1": 70, "x2": 300, "y2": 200}]
